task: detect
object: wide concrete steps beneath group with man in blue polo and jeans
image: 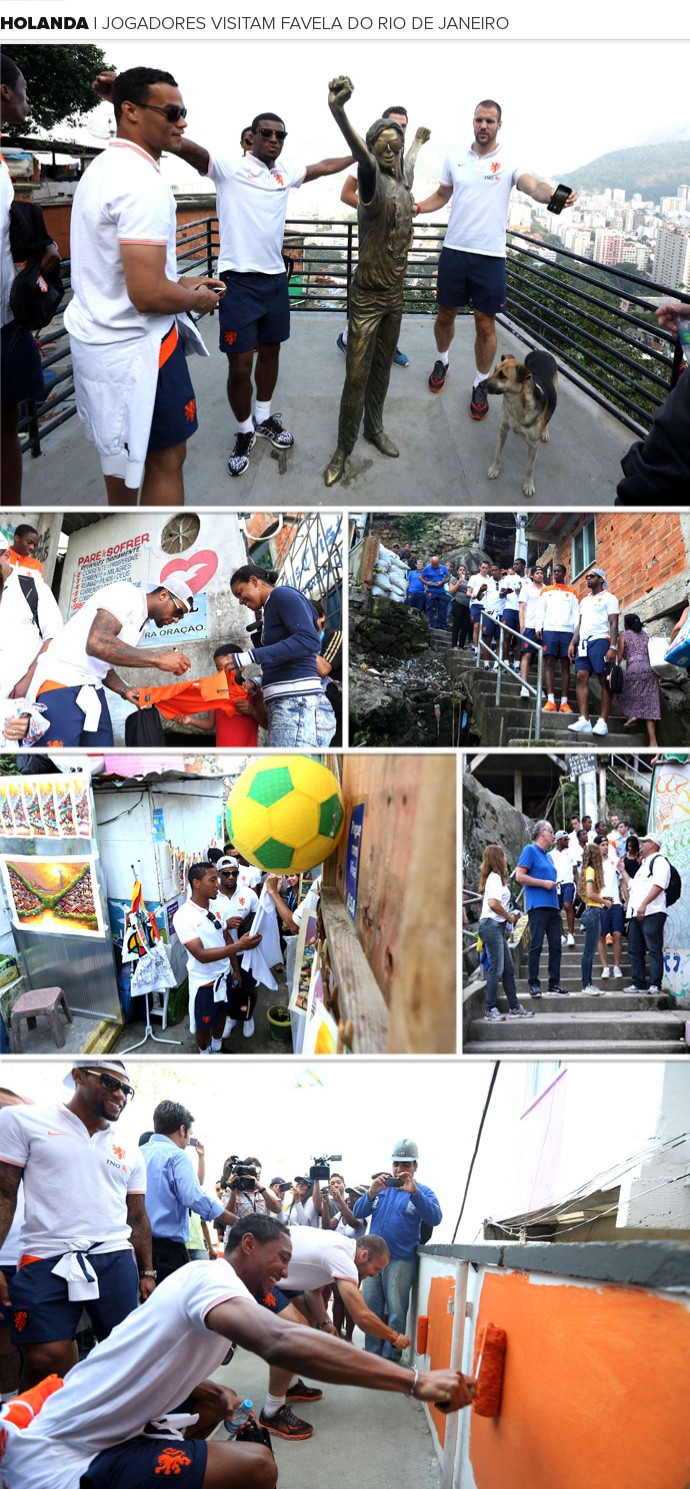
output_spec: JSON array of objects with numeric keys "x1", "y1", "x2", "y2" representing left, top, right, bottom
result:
[{"x1": 463, "y1": 926, "x2": 690, "y2": 1060}]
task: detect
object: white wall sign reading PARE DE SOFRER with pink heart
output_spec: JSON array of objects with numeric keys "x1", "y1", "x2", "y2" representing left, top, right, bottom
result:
[{"x1": 69, "y1": 533, "x2": 211, "y2": 646}]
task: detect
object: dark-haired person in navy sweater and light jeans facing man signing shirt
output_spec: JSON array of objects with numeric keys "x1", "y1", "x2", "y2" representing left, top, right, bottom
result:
[{"x1": 227, "y1": 564, "x2": 335, "y2": 750}]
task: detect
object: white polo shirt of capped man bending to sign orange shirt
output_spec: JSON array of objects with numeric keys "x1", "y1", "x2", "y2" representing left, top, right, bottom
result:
[{"x1": 31, "y1": 579, "x2": 149, "y2": 695}]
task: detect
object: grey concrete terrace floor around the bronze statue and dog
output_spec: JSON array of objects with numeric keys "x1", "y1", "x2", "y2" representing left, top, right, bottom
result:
[{"x1": 22, "y1": 311, "x2": 633, "y2": 511}]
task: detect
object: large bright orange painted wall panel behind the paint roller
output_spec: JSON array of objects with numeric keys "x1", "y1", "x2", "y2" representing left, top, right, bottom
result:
[{"x1": 467, "y1": 1258, "x2": 690, "y2": 1489}]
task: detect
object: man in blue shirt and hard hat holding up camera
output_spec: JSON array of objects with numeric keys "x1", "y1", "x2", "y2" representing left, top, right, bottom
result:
[{"x1": 353, "y1": 1138, "x2": 443, "y2": 1359}]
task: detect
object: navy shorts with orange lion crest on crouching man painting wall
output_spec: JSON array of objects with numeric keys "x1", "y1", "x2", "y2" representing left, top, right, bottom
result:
[{"x1": 79, "y1": 1437, "x2": 209, "y2": 1489}]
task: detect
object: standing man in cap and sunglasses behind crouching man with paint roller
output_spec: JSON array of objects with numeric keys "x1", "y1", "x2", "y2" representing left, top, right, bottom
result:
[{"x1": 0, "y1": 1060, "x2": 155, "y2": 1389}]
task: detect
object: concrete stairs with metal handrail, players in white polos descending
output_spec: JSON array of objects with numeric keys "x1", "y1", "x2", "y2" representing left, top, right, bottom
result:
[{"x1": 431, "y1": 646, "x2": 647, "y2": 750}]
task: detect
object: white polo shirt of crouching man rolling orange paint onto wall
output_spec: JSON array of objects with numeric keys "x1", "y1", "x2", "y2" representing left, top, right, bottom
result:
[{"x1": 3, "y1": 1260, "x2": 253, "y2": 1489}]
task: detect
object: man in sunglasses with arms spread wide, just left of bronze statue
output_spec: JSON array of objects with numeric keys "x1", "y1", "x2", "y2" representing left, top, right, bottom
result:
[{"x1": 180, "y1": 110, "x2": 352, "y2": 476}]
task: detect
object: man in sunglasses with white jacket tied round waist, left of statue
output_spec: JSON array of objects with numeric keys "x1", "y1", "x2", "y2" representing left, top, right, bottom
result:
[{"x1": 64, "y1": 67, "x2": 224, "y2": 506}]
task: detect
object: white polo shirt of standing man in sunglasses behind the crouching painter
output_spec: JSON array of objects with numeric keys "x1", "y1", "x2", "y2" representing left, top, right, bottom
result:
[{"x1": 0, "y1": 1106, "x2": 146, "y2": 1257}]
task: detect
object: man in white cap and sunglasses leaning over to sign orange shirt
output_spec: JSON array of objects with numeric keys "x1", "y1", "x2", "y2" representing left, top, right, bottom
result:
[{"x1": 30, "y1": 576, "x2": 194, "y2": 749}]
